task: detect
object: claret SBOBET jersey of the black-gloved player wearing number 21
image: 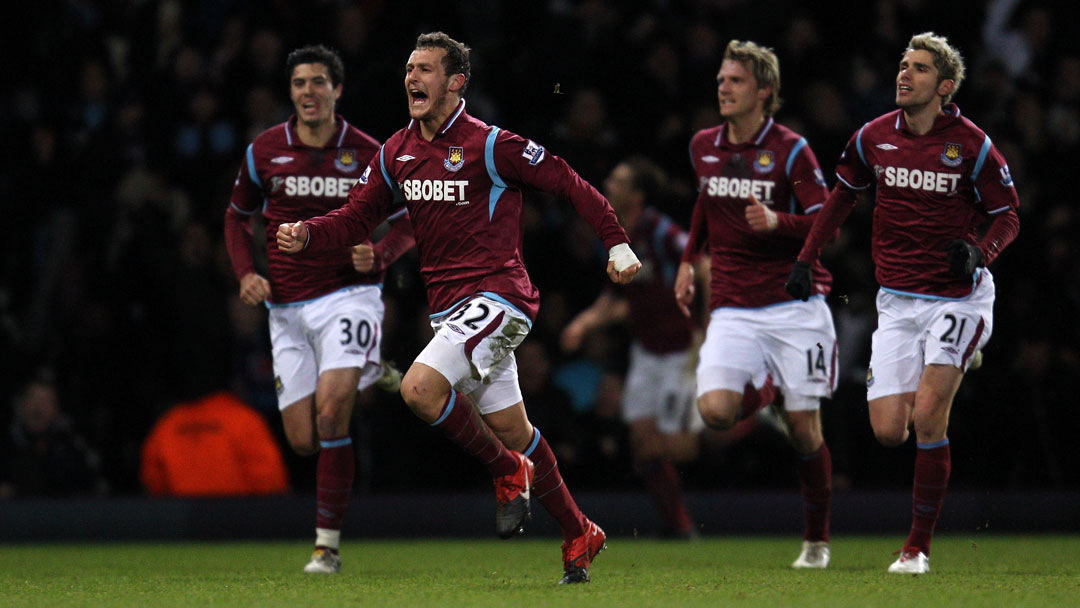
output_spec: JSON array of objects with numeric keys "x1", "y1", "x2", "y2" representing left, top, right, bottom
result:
[{"x1": 836, "y1": 104, "x2": 1020, "y2": 298}]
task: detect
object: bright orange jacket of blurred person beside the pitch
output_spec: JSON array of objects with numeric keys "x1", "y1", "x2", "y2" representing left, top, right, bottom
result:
[{"x1": 139, "y1": 392, "x2": 288, "y2": 496}]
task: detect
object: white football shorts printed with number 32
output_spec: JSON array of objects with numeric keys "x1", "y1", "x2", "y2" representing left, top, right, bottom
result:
[{"x1": 416, "y1": 294, "x2": 532, "y2": 414}]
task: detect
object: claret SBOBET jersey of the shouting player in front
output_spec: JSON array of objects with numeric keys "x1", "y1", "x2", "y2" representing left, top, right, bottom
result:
[{"x1": 307, "y1": 100, "x2": 629, "y2": 319}]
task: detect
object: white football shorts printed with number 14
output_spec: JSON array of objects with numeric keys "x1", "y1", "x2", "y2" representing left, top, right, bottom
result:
[{"x1": 698, "y1": 296, "x2": 837, "y2": 411}]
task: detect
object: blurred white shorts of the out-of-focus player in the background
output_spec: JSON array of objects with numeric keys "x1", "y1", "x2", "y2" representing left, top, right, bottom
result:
[{"x1": 622, "y1": 342, "x2": 705, "y2": 434}]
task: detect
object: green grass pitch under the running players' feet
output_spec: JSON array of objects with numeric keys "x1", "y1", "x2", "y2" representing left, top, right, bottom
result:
[{"x1": 0, "y1": 535, "x2": 1080, "y2": 608}]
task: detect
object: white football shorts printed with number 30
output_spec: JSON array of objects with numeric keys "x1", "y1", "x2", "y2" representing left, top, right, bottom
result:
[{"x1": 270, "y1": 285, "x2": 386, "y2": 409}]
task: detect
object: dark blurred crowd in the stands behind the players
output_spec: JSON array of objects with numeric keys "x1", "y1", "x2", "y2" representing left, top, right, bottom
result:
[{"x1": 0, "y1": 0, "x2": 1080, "y2": 497}]
